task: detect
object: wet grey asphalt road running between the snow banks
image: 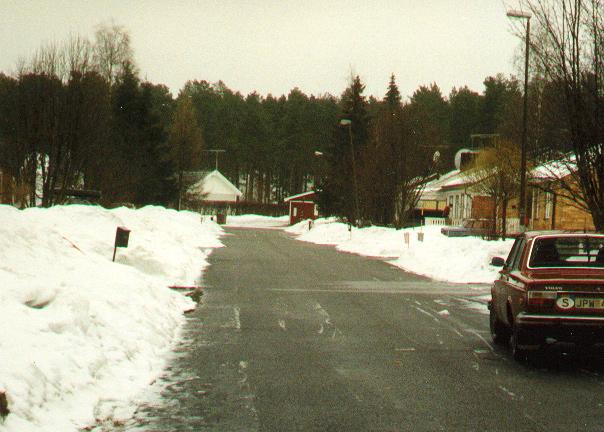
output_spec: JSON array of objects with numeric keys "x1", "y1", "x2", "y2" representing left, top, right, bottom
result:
[{"x1": 123, "y1": 229, "x2": 604, "y2": 431}]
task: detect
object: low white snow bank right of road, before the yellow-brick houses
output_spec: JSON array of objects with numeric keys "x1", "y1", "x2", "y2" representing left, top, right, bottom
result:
[{"x1": 286, "y1": 219, "x2": 513, "y2": 283}]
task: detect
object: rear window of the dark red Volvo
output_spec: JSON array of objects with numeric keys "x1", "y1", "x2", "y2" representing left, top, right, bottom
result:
[{"x1": 529, "y1": 236, "x2": 604, "y2": 268}]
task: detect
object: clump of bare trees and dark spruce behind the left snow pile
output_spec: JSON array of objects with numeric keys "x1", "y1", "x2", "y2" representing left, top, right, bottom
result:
[{"x1": 0, "y1": 24, "x2": 174, "y2": 207}]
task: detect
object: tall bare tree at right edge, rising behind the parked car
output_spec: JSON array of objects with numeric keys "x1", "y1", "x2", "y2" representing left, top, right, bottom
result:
[{"x1": 522, "y1": 0, "x2": 604, "y2": 230}]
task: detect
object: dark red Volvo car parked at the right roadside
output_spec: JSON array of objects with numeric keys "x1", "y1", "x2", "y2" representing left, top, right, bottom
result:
[{"x1": 489, "y1": 231, "x2": 604, "y2": 360}]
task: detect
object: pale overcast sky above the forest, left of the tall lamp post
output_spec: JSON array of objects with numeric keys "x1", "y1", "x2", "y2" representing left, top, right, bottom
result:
[{"x1": 0, "y1": 0, "x2": 520, "y2": 97}]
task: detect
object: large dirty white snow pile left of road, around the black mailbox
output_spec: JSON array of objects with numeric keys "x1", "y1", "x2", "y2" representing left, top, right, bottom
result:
[{"x1": 0, "y1": 206, "x2": 222, "y2": 432}]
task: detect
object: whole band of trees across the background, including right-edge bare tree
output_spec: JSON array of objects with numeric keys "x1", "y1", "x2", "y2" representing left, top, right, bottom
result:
[{"x1": 0, "y1": 0, "x2": 604, "y2": 230}]
